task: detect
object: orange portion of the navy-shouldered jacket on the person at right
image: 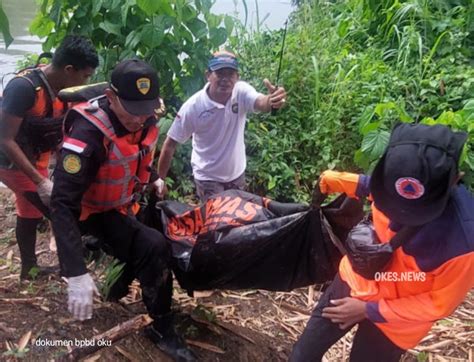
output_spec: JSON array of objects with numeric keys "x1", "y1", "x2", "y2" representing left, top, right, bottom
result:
[{"x1": 339, "y1": 197, "x2": 474, "y2": 349}]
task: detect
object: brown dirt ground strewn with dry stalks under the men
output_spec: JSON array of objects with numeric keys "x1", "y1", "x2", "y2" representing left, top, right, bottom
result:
[{"x1": 0, "y1": 189, "x2": 474, "y2": 361}]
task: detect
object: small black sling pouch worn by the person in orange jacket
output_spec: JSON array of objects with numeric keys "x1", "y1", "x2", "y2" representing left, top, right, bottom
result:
[{"x1": 345, "y1": 220, "x2": 420, "y2": 280}]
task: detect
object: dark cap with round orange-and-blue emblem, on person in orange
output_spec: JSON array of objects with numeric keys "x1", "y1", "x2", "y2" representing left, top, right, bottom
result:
[{"x1": 370, "y1": 123, "x2": 467, "y2": 226}]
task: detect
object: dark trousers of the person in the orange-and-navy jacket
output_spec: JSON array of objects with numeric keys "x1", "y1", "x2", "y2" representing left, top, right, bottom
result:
[{"x1": 290, "y1": 274, "x2": 405, "y2": 362}]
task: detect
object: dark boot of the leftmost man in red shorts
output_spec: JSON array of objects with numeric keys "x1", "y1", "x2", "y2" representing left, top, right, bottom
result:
[{"x1": 15, "y1": 216, "x2": 57, "y2": 280}]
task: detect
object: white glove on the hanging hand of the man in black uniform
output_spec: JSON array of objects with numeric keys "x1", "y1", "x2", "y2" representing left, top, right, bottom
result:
[{"x1": 67, "y1": 273, "x2": 99, "y2": 321}]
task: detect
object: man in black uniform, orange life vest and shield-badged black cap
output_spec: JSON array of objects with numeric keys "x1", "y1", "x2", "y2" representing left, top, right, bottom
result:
[{"x1": 51, "y1": 60, "x2": 194, "y2": 361}]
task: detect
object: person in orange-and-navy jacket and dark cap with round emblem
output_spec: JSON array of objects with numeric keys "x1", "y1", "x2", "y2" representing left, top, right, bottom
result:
[{"x1": 290, "y1": 124, "x2": 474, "y2": 361}]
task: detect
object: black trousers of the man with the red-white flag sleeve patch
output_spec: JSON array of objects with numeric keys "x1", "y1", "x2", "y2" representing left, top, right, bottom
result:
[{"x1": 80, "y1": 210, "x2": 173, "y2": 318}]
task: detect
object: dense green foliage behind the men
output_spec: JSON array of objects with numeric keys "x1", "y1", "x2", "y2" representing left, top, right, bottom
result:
[{"x1": 0, "y1": 0, "x2": 474, "y2": 201}]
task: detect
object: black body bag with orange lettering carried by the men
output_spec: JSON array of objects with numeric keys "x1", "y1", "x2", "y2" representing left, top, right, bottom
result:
[{"x1": 142, "y1": 190, "x2": 363, "y2": 293}]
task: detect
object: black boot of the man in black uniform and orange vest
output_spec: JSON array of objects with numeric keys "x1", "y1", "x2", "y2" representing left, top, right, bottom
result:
[{"x1": 145, "y1": 312, "x2": 197, "y2": 362}]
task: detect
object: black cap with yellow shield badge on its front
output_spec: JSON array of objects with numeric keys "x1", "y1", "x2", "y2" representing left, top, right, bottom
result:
[{"x1": 110, "y1": 59, "x2": 161, "y2": 115}]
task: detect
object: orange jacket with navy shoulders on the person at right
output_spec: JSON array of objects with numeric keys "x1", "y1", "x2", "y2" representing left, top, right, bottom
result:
[{"x1": 339, "y1": 176, "x2": 474, "y2": 349}]
